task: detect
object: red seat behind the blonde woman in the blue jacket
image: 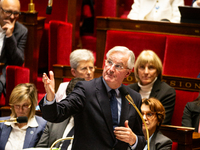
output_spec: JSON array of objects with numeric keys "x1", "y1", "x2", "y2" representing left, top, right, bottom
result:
[{"x1": 0, "y1": 66, "x2": 30, "y2": 106}]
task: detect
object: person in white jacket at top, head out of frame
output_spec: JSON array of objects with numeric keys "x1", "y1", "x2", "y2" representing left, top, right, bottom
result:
[{"x1": 127, "y1": 0, "x2": 184, "y2": 22}]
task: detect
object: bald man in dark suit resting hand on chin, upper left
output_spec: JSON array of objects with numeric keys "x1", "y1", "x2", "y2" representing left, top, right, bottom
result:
[{"x1": 0, "y1": 0, "x2": 28, "y2": 94}]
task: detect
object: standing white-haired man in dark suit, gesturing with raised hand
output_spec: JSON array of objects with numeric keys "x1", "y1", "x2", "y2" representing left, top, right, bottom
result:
[{"x1": 39, "y1": 46, "x2": 146, "y2": 150}]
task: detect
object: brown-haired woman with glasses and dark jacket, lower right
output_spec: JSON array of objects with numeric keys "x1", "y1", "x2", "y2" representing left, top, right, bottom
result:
[{"x1": 141, "y1": 98, "x2": 172, "y2": 150}]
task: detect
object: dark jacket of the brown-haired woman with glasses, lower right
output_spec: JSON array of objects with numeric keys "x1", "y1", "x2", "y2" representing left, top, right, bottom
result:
[{"x1": 150, "y1": 131, "x2": 172, "y2": 150}]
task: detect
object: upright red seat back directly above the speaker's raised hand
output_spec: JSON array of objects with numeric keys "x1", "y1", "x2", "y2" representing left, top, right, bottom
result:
[{"x1": 48, "y1": 20, "x2": 72, "y2": 70}]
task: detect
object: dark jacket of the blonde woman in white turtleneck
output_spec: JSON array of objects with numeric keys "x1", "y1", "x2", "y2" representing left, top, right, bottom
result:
[{"x1": 129, "y1": 79, "x2": 176, "y2": 124}]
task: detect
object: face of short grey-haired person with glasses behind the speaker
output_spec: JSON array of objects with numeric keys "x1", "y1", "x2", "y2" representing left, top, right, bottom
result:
[{"x1": 71, "y1": 60, "x2": 95, "y2": 81}]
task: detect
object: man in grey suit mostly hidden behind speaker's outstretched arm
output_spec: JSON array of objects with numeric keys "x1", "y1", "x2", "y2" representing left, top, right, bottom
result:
[{"x1": 36, "y1": 78, "x2": 84, "y2": 150}]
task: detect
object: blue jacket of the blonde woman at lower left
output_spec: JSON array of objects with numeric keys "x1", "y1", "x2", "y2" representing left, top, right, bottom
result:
[{"x1": 0, "y1": 116, "x2": 46, "y2": 150}]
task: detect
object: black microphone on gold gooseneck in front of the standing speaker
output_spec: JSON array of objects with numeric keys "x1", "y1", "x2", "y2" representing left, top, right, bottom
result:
[{"x1": 119, "y1": 86, "x2": 150, "y2": 150}]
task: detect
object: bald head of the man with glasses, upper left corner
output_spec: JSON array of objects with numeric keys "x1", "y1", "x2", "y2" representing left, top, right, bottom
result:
[{"x1": 0, "y1": 0, "x2": 20, "y2": 22}]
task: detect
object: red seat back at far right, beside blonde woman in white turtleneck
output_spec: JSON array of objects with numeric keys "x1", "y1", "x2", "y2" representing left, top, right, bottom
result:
[{"x1": 163, "y1": 35, "x2": 200, "y2": 78}]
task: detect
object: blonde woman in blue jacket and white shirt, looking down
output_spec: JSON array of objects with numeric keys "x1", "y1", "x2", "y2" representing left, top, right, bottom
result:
[{"x1": 0, "y1": 83, "x2": 47, "y2": 150}]
